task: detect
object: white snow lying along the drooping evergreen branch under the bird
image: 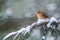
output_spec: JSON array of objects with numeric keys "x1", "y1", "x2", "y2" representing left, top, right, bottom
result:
[{"x1": 3, "y1": 17, "x2": 60, "y2": 40}]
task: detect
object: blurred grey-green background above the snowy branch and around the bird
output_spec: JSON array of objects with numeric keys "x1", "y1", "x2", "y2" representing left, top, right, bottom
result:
[{"x1": 0, "y1": 0, "x2": 60, "y2": 40}]
